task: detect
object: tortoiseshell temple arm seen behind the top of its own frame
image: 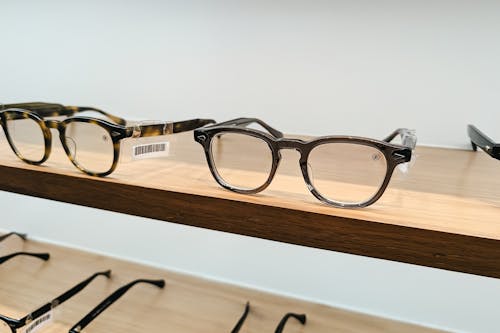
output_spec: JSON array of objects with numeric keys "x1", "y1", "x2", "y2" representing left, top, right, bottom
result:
[{"x1": 2, "y1": 102, "x2": 127, "y2": 126}]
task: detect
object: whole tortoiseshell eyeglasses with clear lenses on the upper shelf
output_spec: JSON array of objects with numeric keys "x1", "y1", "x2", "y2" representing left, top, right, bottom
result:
[{"x1": 0, "y1": 102, "x2": 215, "y2": 177}]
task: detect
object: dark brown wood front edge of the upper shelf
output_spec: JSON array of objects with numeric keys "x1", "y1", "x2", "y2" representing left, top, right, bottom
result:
[{"x1": 0, "y1": 165, "x2": 500, "y2": 278}]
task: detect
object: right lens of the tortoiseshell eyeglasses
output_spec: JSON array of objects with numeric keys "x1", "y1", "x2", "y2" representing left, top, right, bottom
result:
[{"x1": 65, "y1": 121, "x2": 114, "y2": 173}]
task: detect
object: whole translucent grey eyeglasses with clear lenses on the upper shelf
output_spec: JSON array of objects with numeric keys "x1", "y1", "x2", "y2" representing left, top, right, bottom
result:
[{"x1": 194, "y1": 118, "x2": 416, "y2": 207}]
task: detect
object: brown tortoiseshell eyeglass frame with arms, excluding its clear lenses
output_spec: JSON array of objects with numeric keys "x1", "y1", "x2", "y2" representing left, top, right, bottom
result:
[{"x1": 0, "y1": 102, "x2": 215, "y2": 177}]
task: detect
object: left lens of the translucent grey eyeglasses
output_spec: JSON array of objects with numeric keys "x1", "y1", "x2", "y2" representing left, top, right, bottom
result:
[{"x1": 210, "y1": 132, "x2": 273, "y2": 190}]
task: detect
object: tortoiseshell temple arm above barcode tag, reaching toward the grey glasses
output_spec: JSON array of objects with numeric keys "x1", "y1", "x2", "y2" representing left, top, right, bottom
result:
[{"x1": 127, "y1": 118, "x2": 215, "y2": 138}]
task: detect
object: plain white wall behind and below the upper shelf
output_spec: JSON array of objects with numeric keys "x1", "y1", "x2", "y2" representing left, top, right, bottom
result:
[{"x1": 0, "y1": 0, "x2": 500, "y2": 332}]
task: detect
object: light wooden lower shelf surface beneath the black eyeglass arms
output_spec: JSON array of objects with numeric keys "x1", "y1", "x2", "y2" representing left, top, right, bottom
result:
[{"x1": 0, "y1": 238, "x2": 441, "y2": 333}]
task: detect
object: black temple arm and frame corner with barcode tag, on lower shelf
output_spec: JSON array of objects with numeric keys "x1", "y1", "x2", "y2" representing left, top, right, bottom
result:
[{"x1": 0, "y1": 271, "x2": 111, "y2": 333}]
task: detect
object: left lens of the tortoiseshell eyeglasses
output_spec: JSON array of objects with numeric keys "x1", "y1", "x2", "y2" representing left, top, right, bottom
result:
[{"x1": 6, "y1": 118, "x2": 45, "y2": 162}]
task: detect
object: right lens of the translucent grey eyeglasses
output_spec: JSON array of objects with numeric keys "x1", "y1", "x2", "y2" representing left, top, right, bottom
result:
[{"x1": 308, "y1": 143, "x2": 387, "y2": 204}]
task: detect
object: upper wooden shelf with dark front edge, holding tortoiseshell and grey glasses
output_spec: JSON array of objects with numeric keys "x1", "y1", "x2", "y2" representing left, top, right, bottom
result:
[{"x1": 0, "y1": 133, "x2": 500, "y2": 278}]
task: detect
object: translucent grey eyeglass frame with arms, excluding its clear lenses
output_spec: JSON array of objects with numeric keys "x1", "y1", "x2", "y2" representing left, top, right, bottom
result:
[{"x1": 194, "y1": 118, "x2": 417, "y2": 208}]
